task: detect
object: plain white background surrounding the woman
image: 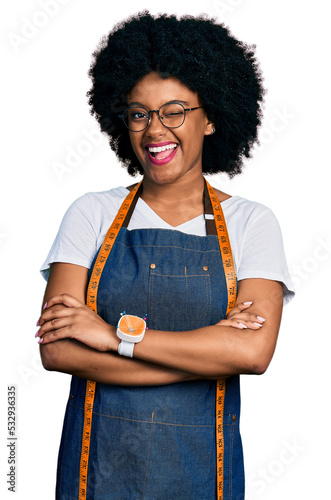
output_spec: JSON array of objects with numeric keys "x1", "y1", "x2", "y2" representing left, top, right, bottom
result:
[{"x1": 0, "y1": 0, "x2": 331, "y2": 500}]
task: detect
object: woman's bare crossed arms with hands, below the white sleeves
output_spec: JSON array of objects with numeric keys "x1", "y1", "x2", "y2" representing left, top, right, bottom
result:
[{"x1": 36, "y1": 263, "x2": 283, "y2": 385}]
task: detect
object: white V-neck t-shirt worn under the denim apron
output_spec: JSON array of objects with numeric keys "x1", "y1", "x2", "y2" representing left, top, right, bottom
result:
[{"x1": 41, "y1": 187, "x2": 294, "y2": 303}]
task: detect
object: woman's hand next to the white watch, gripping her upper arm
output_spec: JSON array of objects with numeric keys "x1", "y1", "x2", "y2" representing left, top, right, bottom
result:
[{"x1": 36, "y1": 293, "x2": 117, "y2": 351}]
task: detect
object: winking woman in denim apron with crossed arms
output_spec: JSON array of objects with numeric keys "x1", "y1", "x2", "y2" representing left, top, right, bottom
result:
[{"x1": 36, "y1": 12, "x2": 292, "y2": 500}]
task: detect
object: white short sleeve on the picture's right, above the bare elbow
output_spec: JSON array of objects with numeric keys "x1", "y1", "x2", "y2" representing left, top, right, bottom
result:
[{"x1": 238, "y1": 204, "x2": 294, "y2": 304}]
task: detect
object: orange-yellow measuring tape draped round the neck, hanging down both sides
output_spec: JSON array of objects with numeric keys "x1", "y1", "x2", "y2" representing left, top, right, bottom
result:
[{"x1": 79, "y1": 181, "x2": 237, "y2": 500}]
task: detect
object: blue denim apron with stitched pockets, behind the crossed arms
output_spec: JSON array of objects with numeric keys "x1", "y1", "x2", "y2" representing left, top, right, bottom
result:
[{"x1": 56, "y1": 182, "x2": 244, "y2": 500}]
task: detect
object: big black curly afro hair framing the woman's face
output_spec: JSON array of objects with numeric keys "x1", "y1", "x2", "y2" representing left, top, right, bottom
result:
[{"x1": 87, "y1": 11, "x2": 264, "y2": 177}]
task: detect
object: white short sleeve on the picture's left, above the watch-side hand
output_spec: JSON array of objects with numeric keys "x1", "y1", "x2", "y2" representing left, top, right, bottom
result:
[{"x1": 40, "y1": 194, "x2": 97, "y2": 280}]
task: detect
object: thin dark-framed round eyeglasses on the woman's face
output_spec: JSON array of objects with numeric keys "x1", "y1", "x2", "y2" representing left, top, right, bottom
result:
[{"x1": 119, "y1": 102, "x2": 203, "y2": 132}]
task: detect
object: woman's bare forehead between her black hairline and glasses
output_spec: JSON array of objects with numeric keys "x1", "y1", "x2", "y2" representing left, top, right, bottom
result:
[{"x1": 128, "y1": 72, "x2": 199, "y2": 107}]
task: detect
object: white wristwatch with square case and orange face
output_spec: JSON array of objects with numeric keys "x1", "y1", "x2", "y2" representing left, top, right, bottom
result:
[{"x1": 116, "y1": 311, "x2": 146, "y2": 358}]
